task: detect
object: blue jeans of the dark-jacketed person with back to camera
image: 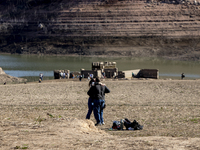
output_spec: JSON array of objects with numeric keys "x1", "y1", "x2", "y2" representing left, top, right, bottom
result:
[{"x1": 94, "y1": 99, "x2": 105, "y2": 123}]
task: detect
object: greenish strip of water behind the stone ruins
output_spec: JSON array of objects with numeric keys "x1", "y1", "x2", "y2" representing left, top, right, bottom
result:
[{"x1": 0, "y1": 55, "x2": 200, "y2": 79}]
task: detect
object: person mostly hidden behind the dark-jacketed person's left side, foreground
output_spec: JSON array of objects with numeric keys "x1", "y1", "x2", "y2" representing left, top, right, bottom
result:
[{"x1": 86, "y1": 78, "x2": 95, "y2": 119}]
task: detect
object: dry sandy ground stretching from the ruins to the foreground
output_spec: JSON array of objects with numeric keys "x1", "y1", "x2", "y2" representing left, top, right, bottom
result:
[{"x1": 0, "y1": 79, "x2": 200, "y2": 150}]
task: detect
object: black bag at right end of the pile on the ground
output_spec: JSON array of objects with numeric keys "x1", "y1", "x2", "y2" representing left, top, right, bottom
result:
[{"x1": 124, "y1": 118, "x2": 143, "y2": 130}]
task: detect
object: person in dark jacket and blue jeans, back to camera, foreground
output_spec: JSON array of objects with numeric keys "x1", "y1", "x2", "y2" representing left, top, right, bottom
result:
[{"x1": 87, "y1": 77, "x2": 110, "y2": 126}]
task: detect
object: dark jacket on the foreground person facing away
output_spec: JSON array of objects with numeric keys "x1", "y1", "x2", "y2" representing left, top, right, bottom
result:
[{"x1": 87, "y1": 83, "x2": 110, "y2": 100}]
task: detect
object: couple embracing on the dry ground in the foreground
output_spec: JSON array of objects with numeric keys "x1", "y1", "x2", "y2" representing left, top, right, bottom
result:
[{"x1": 86, "y1": 77, "x2": 110, "y2": 126}]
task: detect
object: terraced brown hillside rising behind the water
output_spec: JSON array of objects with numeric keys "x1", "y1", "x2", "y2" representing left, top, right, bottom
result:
[{"x1": 0, "y1": 0, "x2": 200, "y2": 60}]
